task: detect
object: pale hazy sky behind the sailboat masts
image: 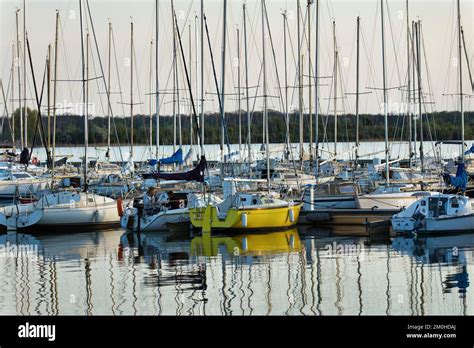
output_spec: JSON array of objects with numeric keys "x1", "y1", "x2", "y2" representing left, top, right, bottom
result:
[{"x1": 0, "y1": 0, "x2": 474, "y2": 115}]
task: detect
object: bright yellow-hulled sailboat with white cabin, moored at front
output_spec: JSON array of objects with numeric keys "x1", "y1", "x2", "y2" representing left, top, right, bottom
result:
[{"x1": 189, "y1": 193, "x2": 301, "y2": 232}]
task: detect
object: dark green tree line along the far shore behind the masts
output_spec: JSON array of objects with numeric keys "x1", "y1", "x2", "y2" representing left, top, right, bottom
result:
[{"x1": 0, "y1": 108, "x2": 474, "y2": 147}]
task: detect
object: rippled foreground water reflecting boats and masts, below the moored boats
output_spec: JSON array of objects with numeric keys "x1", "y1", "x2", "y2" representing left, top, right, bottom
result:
[{"x1": 0, "y1": 228, "x2": 474, "y2": 315}]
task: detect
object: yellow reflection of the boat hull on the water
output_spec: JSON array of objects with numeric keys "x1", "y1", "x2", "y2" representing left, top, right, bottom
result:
[{"x1": 191, "y1": 229, "x2": 302, "y2": 256}]
